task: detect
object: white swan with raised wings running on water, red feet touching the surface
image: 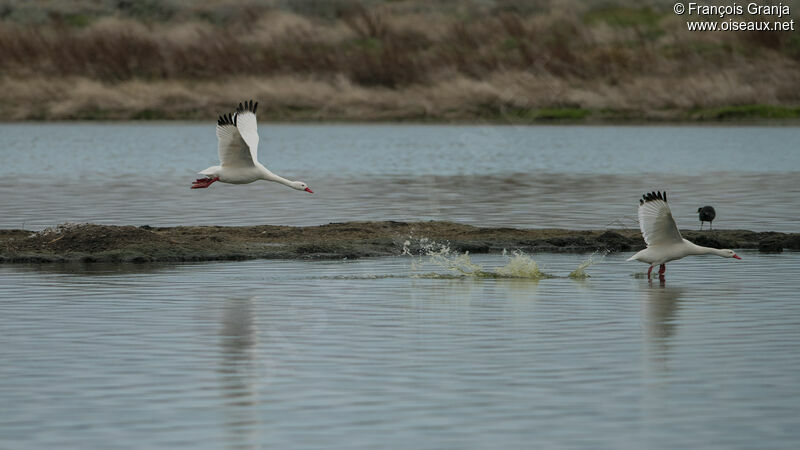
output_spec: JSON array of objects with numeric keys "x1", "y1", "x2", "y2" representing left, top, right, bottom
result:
[{"x1": 628, "y1": 192, "x2": 742, "y2": 279}]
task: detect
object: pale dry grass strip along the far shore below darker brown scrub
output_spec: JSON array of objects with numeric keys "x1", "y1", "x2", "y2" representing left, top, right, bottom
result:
[{"x1": 0, "y1": 68, "x2": 800, "y2": 122}]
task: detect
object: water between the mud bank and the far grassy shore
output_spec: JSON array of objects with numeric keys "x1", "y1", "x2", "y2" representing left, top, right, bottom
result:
[{"x1": 0, "y1": 123, "x2": 800, "y2": 231}]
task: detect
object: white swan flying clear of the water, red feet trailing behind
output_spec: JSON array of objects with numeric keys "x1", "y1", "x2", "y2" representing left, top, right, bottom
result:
[{"x1": 192, "y1": 100, "x2": 314, "y2": 194}]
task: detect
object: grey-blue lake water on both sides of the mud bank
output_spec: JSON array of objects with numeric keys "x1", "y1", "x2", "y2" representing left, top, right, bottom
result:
[{"x1": 0, "y1": 123, "x2": 800, "y2": 449}]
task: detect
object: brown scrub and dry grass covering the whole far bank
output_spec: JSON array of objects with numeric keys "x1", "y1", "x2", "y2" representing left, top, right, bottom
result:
[{"x1": 0, "y1": 0, "x2": 800, "y2": 122}]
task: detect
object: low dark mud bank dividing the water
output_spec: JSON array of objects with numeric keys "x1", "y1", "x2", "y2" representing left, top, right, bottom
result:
[{"x1": 0, "y1": 221, "x2": 800, "y2": 263}]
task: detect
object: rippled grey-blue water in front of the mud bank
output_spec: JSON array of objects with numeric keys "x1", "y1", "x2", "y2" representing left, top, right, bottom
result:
[{"x1": 0, "y1": 252, "x2": 800, "y2": 449}]
